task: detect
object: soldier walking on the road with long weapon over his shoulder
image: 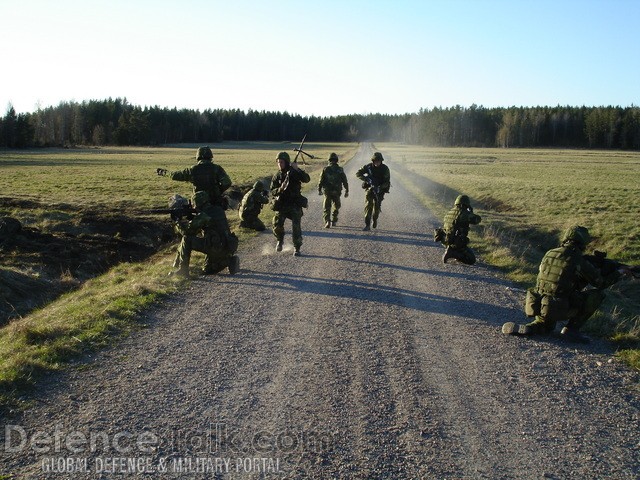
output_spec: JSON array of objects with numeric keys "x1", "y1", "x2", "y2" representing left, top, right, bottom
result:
[{"x1": 271, "y1": 152, "x2": 311, "y2": 257}]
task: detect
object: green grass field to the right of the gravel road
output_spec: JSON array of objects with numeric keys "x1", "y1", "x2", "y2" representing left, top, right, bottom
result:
[{"x1": 378, "y1": 144, "x2": 640, "y2": 369}]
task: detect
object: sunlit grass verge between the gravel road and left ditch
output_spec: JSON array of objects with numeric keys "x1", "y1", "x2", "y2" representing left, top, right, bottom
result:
[{"x1": 0, "y1": 254, "x2": 184, "y2": 406}]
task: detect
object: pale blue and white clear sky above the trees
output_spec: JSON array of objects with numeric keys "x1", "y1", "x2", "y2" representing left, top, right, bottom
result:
[{"x1": 0, "y1": 0, "x2": 640, "y2": 117}]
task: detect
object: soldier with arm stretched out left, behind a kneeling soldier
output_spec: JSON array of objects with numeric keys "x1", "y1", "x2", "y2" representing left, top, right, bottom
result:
[{"x1": 157, "y1": 147, "x2": 231, "y2": 210}]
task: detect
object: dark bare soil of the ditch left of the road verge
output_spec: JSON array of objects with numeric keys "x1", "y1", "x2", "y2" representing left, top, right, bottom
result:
[{"x1": 0, "y1": 199, "x2": 174, "y2": 325}]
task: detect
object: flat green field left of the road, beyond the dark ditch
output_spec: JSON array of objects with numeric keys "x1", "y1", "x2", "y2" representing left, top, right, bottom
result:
[{"x1": 0, "y1": 142, "x2": 356, "y2": 212}]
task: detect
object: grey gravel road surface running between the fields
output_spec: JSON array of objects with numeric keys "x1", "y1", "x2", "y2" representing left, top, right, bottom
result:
[{"x1": 0, "y1": 145, "x2": 640, "y2": 479}]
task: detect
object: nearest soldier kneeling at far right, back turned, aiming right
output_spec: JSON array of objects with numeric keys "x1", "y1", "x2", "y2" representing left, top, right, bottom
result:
[{"x1": 502, "y1": 225, "x2": 626, "y2": 343}]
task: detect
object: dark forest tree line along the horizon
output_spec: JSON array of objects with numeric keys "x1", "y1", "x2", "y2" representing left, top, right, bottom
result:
[{"x1": 0, "y1": 98, "x2": 640, "y2": 150}]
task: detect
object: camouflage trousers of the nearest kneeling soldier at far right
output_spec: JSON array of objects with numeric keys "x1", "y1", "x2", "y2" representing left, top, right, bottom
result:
[{"x1": 527, "y1": 289, "x2": 605, "y2": 334}]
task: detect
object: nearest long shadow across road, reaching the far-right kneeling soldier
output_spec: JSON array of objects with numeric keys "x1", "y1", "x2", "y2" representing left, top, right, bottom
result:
[{"x1": 230, "y1": 270, "x2": 521, "y2": 324}]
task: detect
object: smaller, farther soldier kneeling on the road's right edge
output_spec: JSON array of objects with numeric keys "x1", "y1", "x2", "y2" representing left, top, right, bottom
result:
[{"x1": 442, "y1": 195, "x2": 481, "y2": 265}]
